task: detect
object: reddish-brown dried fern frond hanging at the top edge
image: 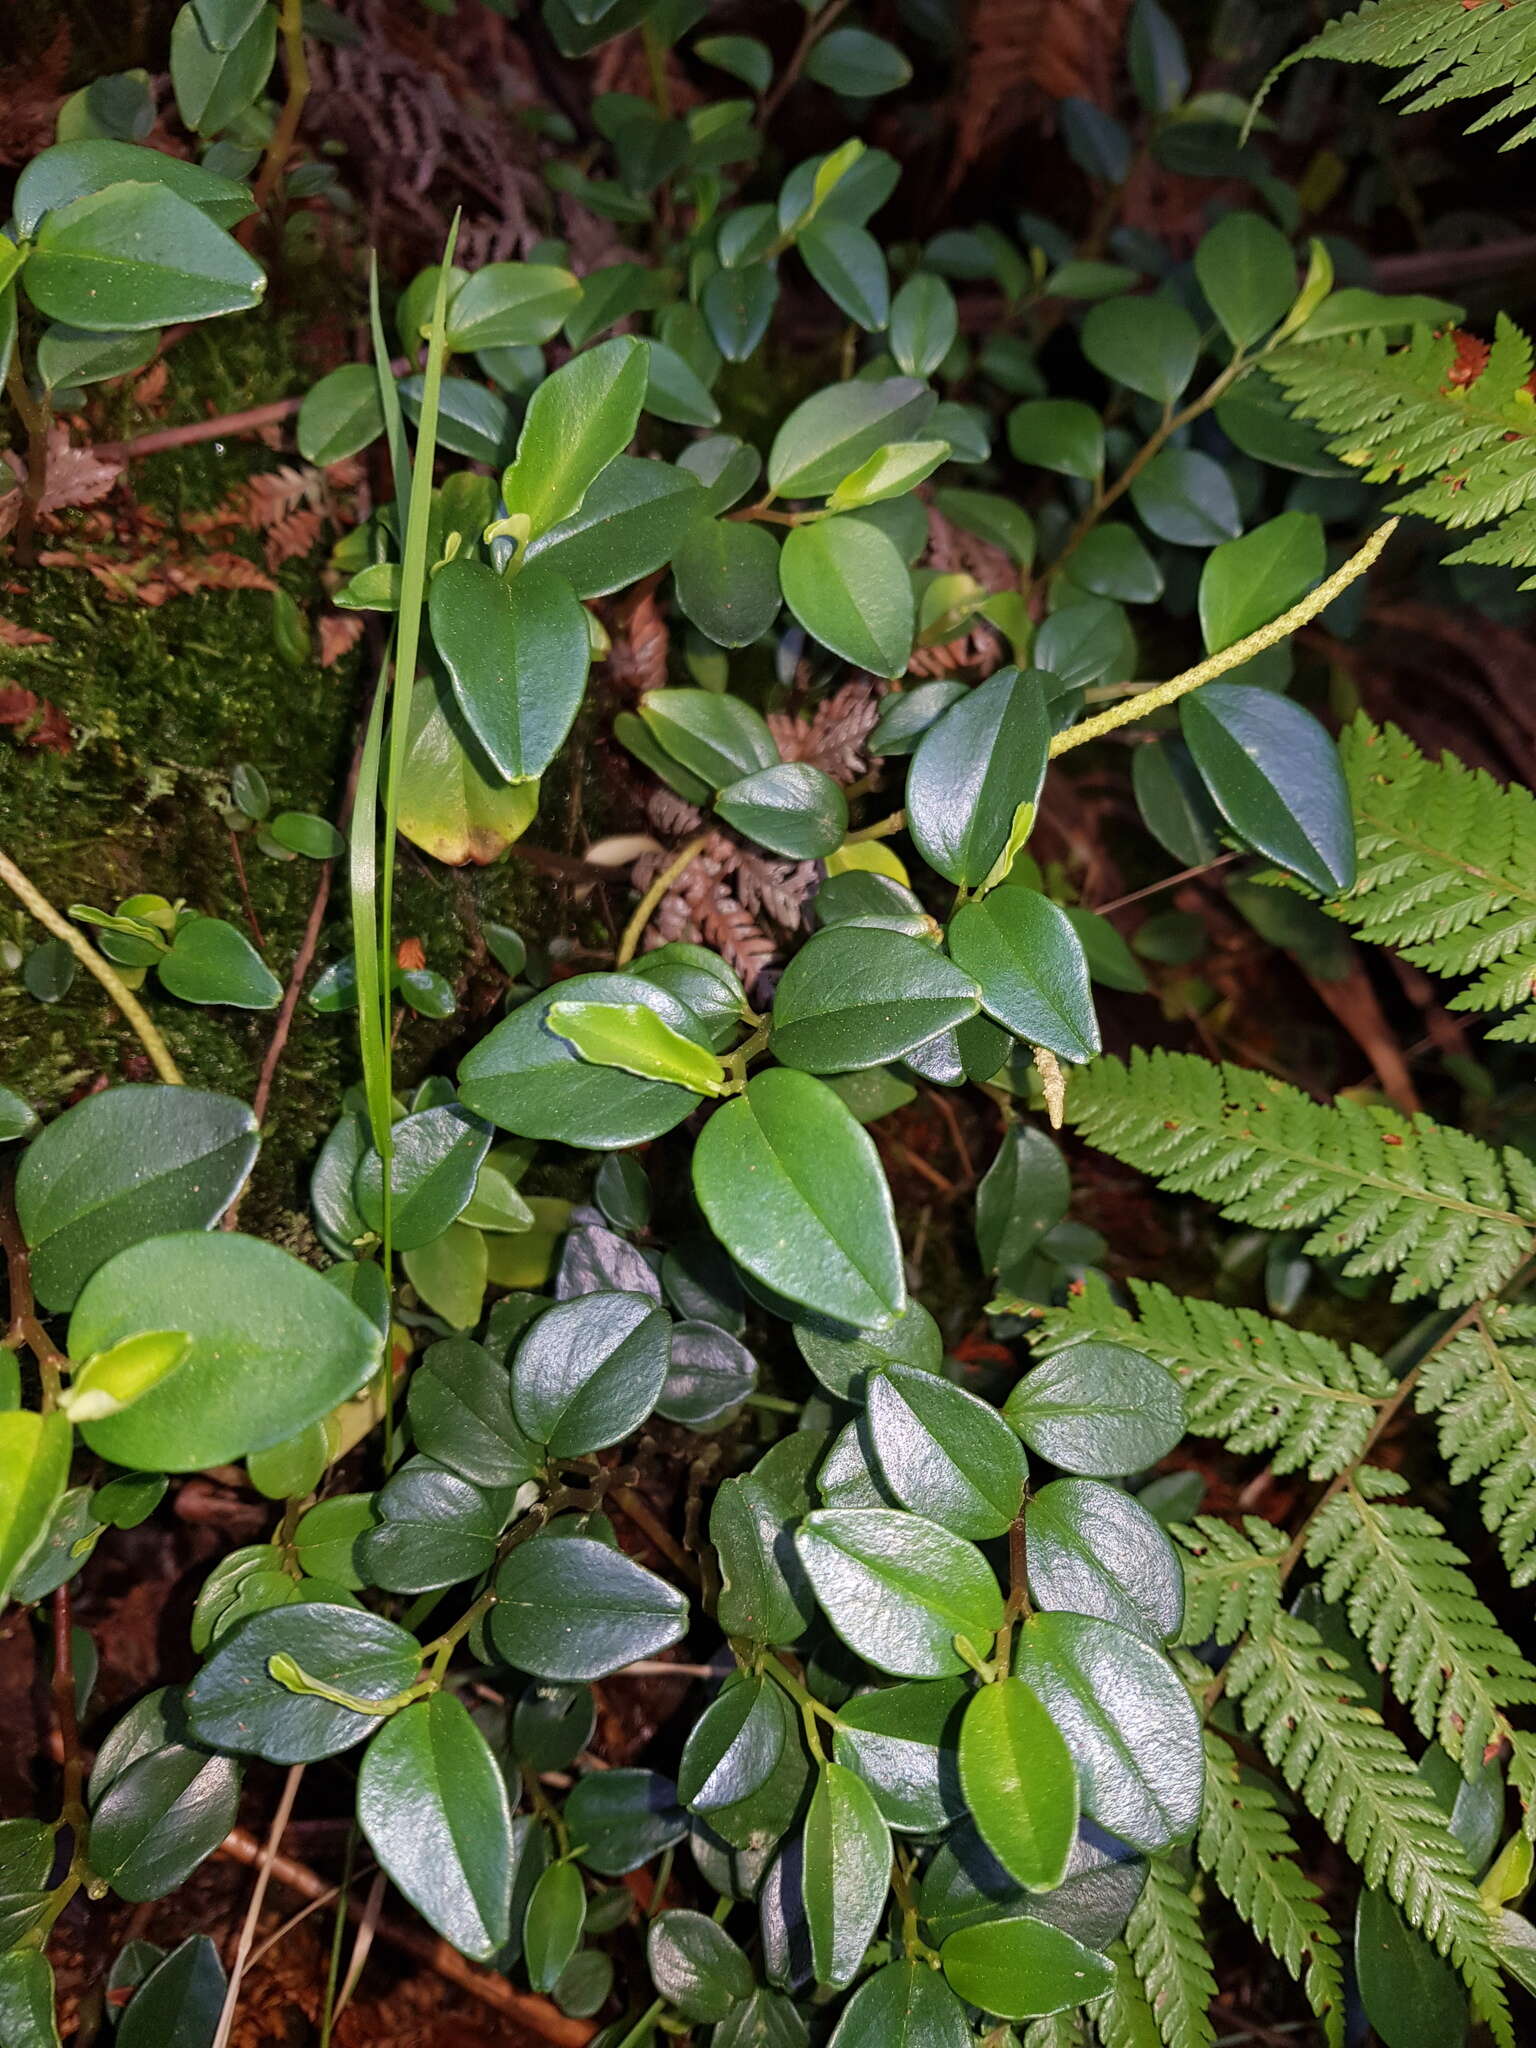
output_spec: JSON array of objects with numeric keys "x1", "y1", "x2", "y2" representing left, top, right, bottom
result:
[{"x1": 948, "y1": 0, "x2": 1128, "y2": 193}]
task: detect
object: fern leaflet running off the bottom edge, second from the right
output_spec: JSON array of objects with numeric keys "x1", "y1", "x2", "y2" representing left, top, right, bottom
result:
[{"x1": 1194, "y1": 1729, "x2": 1343, "y2": 2048}]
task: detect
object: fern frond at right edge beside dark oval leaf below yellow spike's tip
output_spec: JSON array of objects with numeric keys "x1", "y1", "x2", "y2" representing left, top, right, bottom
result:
[{"x1": 1325, "y1": 720, "x2": 1536, "y2": 1040}]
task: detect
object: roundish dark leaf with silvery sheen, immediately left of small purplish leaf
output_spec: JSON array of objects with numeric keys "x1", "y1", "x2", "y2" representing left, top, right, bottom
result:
[{"x1": 512, "y1": 1292, "x2": 670, "y2": 1458}]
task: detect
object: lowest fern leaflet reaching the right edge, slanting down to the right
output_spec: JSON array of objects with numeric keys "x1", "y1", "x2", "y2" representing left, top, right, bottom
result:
[{"x1": 1307, "y1": 1464, "x2": 1536, "y2": 1780}]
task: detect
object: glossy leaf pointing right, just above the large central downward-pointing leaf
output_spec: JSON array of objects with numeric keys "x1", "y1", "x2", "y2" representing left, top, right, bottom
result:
[{"x1": 770, "y1": 926, "x2": 977, "y2": 1073}]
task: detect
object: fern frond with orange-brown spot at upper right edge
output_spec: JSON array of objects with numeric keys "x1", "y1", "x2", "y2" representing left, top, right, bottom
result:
[{"x1": 1266, "y1": 315, "x2": 1536, "y2": 588}]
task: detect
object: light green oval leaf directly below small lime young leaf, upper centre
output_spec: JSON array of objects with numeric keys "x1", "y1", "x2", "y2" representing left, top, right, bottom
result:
[{"x1": 778, "y1": 514, "x2": 915, "y2": 676}]
